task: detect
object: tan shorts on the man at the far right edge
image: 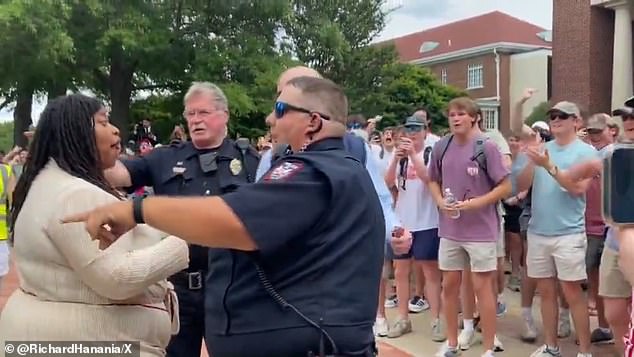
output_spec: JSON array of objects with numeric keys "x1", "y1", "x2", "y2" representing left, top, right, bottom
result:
[{"x1": 599, "y1": 247, "x2": 632, "y2": 299}]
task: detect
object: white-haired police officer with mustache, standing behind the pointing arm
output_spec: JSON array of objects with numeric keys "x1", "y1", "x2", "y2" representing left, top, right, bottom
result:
[{"x1": 107, "y1": 83, "x2": 259, "y2": 357}]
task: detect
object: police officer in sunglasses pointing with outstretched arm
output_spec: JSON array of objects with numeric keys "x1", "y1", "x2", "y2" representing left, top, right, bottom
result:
[{"x1": 71, "y1": 77, "x2": 385, "y2": 357}]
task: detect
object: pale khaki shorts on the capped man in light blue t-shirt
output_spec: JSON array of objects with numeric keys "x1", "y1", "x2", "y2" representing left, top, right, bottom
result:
[{"x1": 526, "y1": 232, "x2": 588, "y2": 281}]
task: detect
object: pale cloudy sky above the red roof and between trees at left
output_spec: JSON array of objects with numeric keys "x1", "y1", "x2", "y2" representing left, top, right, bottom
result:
[{"x1": 0, "y1": 0, "x2": 553, "y2": 122}]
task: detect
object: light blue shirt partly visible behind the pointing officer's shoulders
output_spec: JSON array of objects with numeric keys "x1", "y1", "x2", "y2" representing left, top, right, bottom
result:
[{"x1": 256, "y1": 141, "x2": 400, "y2": 240}]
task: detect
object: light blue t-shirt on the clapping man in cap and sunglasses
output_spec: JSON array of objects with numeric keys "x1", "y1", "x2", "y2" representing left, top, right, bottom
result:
[{"x1": 528, "y1": 139, "x2": 598, "y2": 237}]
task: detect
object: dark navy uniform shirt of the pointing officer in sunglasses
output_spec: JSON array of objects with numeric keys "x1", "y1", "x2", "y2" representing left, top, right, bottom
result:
[{"x1": 205, "y1": 139, "x2": 385, "y2": 357}]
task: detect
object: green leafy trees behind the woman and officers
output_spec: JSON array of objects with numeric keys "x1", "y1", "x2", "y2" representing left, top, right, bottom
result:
[{"x1": 0, "y1": 0, "x2": 460, "y2": 145}]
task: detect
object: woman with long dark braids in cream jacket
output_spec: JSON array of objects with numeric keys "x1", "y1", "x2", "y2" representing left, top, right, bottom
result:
[{"x1": 0, "y1": 94, "x2": 188, "y2": 356}]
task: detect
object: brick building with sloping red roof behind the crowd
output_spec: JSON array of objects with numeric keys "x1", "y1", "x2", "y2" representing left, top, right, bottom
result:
[{"x1": 384, "y1": 11, "x2": 551, "y2": 131}]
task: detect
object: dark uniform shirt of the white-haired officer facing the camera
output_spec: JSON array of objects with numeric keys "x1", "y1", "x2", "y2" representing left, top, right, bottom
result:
[{"x1": 122, "y1": 139, "x2": 259, "y2": 271}]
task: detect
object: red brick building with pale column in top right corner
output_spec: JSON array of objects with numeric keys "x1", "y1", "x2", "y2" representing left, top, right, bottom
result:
[{"x1": 552, "y1": 0, "x2": 634, "y2": 113}]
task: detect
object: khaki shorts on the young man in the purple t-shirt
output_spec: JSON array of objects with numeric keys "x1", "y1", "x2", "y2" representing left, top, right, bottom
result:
[{"x1": 438, "y1": 238, "x2": 497, "y2": 273}]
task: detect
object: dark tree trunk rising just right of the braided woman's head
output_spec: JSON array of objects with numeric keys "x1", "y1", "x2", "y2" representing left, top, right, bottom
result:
[{"x1": 108, "y1": 50, "x2": 134, "y2": 142}]
